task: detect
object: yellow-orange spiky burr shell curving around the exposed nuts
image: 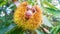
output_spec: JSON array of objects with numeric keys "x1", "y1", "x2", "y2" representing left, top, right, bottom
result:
[{"x1": 13, "y1": 2, "x2": 42, "y2": 30}]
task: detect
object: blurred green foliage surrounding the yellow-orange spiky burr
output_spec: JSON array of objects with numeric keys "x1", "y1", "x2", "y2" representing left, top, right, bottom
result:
[{"x1": 0, "y1": 0, "x2": 60, "y2": 34}]
